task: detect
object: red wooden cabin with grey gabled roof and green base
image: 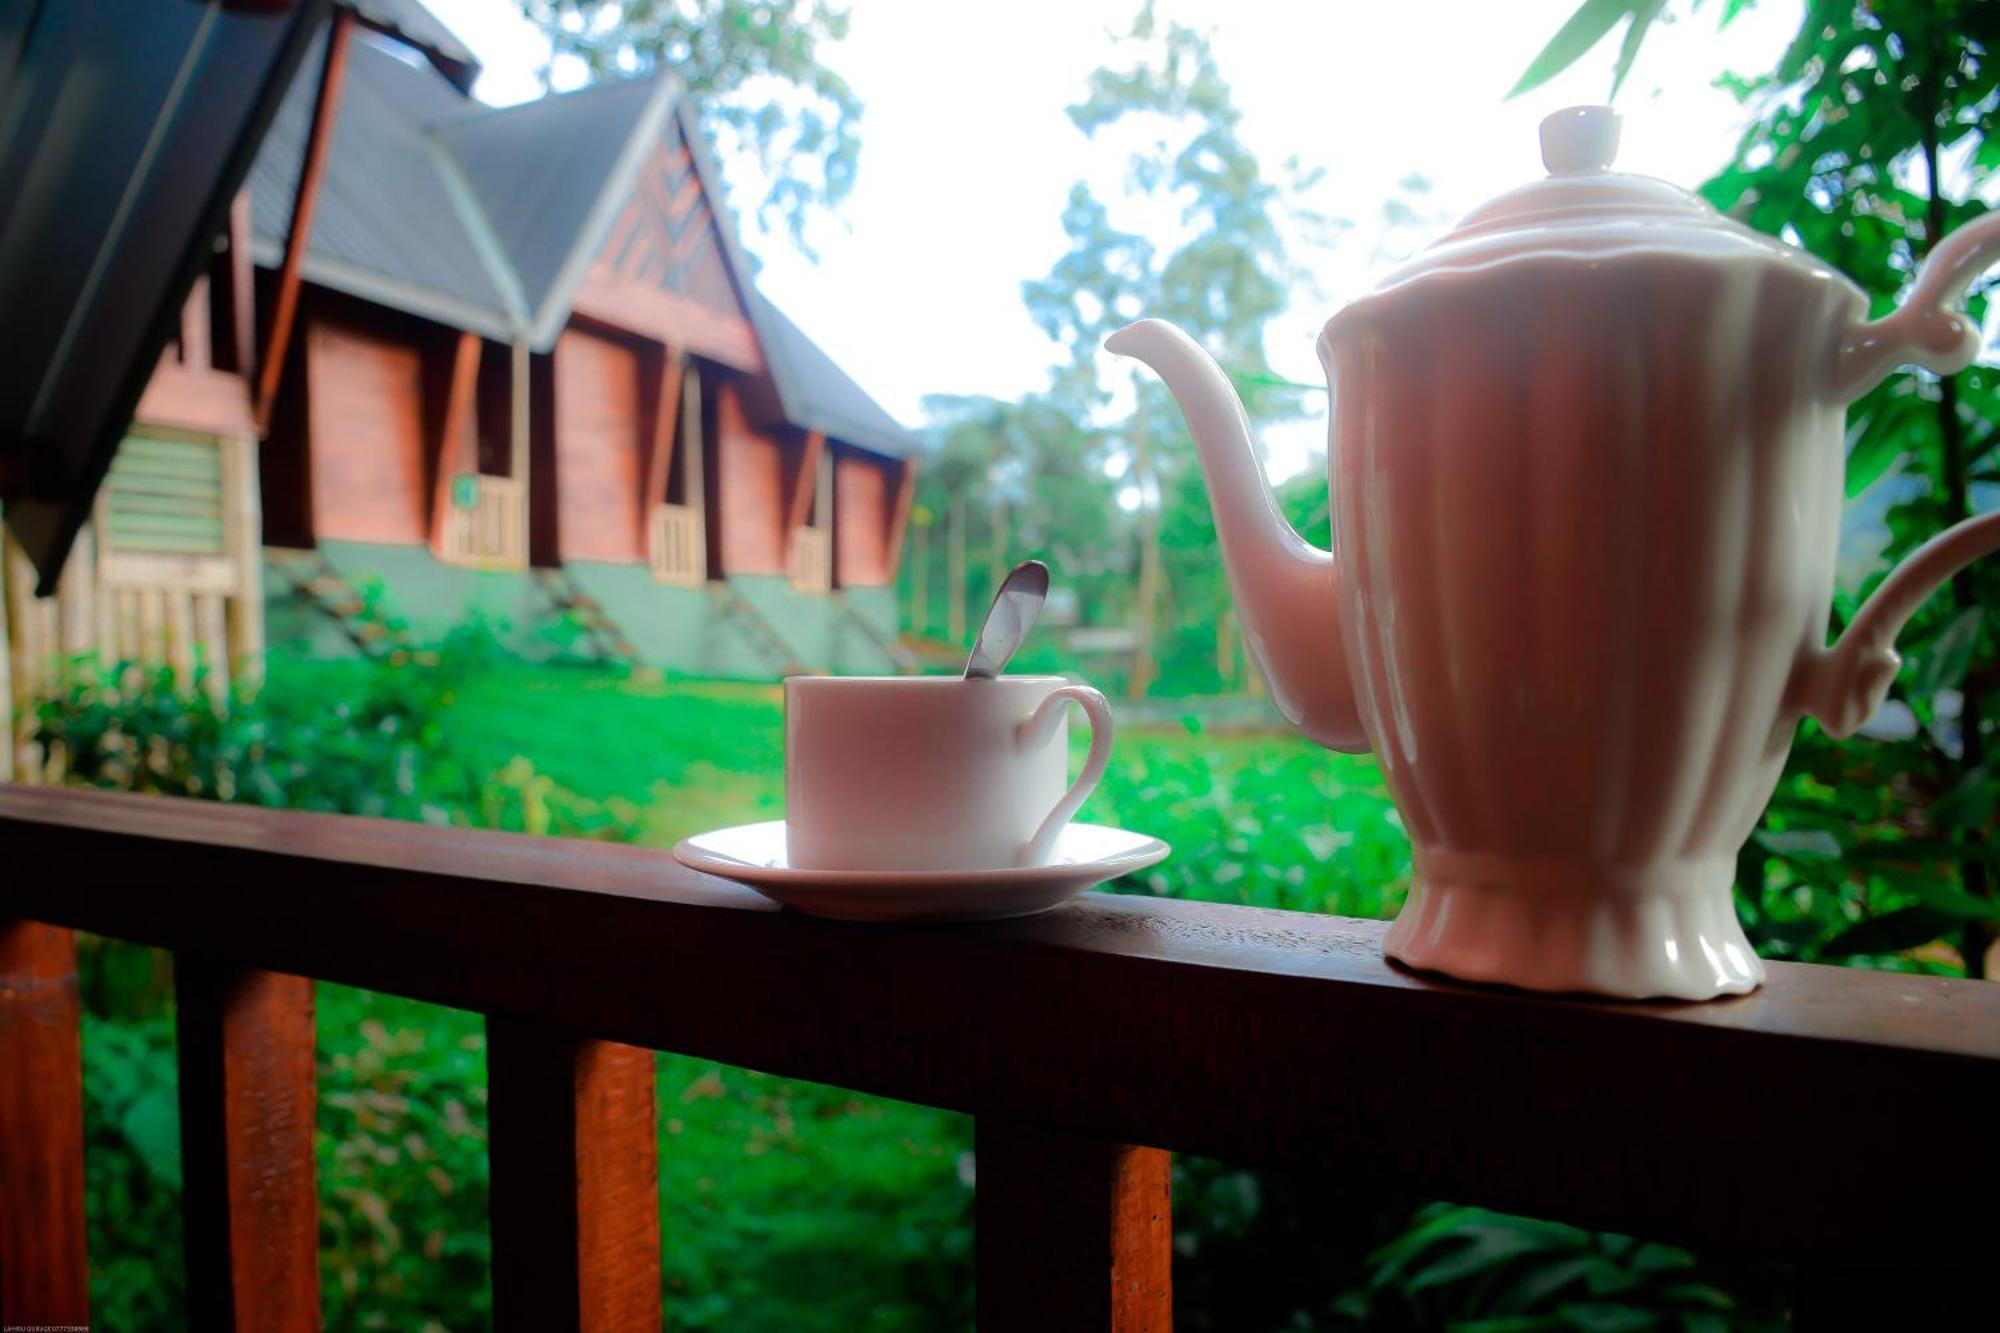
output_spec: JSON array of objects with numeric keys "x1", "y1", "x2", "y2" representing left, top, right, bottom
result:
[{"x1": 248, "y1": 0, "x2": 920, "y2": 677}]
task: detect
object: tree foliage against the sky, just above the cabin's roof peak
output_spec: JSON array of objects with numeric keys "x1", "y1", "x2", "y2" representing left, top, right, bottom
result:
[{"x1": 520, "y1": 0, "x2": 862, "y2": 252}]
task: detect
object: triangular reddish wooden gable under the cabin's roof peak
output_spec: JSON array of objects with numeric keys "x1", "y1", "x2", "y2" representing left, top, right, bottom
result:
[{"x1": 572, "y1": 116, "x2": 764, "y2": 374}]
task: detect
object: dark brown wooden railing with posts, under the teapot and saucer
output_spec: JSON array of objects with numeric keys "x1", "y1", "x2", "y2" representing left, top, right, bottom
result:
[{"x1": 0, "y1": 787, "x2": 2000, "y2": 1333}]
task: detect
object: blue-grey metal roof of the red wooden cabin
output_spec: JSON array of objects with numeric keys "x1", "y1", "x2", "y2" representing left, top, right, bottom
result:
[{"x1": 250, "y1": 0, "x2": 924, "y2": 458}]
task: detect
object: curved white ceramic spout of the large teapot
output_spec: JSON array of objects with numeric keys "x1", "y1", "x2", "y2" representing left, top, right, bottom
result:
[{"x1": 1104, "y1": 320, "x2": 1368, "y2": 753}]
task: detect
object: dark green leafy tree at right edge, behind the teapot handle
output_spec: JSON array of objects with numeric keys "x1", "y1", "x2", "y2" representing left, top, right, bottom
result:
[{"x1": 1544, "y1": 0, "x2": 2000, "y2": 975}]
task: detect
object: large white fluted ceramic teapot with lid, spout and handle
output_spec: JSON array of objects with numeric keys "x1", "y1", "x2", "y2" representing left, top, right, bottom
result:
[{"x1": 1106, "y1": 106, "x2": 2000, "y2": 999}]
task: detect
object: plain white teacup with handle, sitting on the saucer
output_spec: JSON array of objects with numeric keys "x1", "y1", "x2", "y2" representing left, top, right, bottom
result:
[{"x1": 784, "y1": 677, "x2": 1112, "y2": 871}]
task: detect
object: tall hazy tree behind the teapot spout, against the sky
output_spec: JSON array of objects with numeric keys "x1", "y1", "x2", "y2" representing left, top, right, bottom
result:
[{"x1": 904, "y1": 4, "x2": 1330, "y2": 693}]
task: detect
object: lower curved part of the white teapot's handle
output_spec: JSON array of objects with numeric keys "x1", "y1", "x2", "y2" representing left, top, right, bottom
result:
[{"x1": 1788, "y1": 512, "x2": 2000, "y2": 741}]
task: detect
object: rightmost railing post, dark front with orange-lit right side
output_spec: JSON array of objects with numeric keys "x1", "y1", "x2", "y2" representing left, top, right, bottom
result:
[{"x1": 974, "y1": 1117, "x2": 1174, "y2": 1333}]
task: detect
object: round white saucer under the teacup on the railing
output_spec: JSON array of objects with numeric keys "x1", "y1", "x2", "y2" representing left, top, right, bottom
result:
[{"x1": 674, "y1": 819, "x2": 1168, "y2": 921}]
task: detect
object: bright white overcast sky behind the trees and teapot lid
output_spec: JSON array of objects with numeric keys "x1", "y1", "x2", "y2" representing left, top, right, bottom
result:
[{"x1": 428, "y1": 0, "x2": 1800, "y2": 472}]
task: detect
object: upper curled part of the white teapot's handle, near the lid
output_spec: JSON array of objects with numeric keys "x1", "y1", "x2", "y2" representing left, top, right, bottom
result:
[{"x1": 1834, "y1": 212, "x2": 2000, "y2": 400}]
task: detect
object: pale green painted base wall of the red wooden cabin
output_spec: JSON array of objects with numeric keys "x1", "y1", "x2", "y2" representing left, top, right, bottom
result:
[{"x1": 264, "y1": 542, "x2": 896, "y2": 681}]
